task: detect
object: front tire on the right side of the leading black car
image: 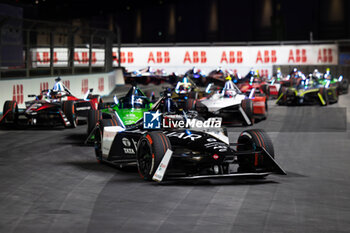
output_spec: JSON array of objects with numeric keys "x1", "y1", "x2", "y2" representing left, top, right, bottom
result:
[{"x1": 237, "y1": 129, "x2": 275, "y2": 172}]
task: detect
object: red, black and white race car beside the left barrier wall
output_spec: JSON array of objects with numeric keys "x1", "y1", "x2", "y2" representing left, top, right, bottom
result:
[{"x1": 0, "y1": 89, "x2": 102, "y2": 128}]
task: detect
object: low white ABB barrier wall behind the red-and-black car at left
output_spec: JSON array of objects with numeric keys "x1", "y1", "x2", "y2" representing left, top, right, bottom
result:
[{"x1": 0, "y1": 71, "x2": 119, "y2": 112}]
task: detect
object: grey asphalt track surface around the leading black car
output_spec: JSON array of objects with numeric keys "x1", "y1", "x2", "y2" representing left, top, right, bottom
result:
[{"x1": 0, "y1": 91, "x2": 350, "y2": 233}]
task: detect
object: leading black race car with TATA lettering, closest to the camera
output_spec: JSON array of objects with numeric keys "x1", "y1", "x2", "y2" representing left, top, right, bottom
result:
[{"x1": 94, "y1": 93, "x2": 286, "y2": 182}]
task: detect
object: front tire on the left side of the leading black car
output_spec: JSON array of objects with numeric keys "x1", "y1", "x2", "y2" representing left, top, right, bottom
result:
[{"x1": 137, "y1": 132, "x2": 171, "y2": 180}]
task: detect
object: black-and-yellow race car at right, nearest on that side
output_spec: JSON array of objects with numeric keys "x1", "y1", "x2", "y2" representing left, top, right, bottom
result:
[{"x1": 276, "y1": 77, "x2": 338, "y2": 106}]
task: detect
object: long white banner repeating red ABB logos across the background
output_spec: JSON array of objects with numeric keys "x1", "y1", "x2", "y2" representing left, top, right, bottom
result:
[{"x1": 32, "y1": 44, "x2": 338, "y2": 73}]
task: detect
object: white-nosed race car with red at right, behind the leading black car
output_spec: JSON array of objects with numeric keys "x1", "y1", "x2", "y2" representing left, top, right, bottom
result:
[{"x1": 193, "y1": 83, "x2": 267, "y2": 126}]
